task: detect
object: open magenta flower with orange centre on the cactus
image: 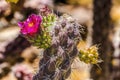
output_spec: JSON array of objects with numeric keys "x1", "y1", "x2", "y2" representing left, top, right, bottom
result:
[{"x1": 18, "y1": 14, "x2": 42, "y2": 36}]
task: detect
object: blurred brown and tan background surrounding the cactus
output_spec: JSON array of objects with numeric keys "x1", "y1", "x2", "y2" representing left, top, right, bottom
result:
[{"x1": 0, "y1": 0, "x2": 120, "y2": 80}]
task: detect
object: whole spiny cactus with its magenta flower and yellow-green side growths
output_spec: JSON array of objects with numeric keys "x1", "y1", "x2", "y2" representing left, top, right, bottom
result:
[{"x1": 18, "y1": 7, "x2": 98, "y2": 80}]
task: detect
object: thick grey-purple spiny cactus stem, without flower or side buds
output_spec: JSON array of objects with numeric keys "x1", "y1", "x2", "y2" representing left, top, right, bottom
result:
[{"x1": 33, "y1": 15, "x2": 81, "y2": 80}]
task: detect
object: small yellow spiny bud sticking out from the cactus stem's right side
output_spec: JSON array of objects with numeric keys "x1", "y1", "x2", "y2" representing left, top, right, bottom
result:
[{"x1": 78, "y1": 45, "x2": 102, "y2": 64}]
